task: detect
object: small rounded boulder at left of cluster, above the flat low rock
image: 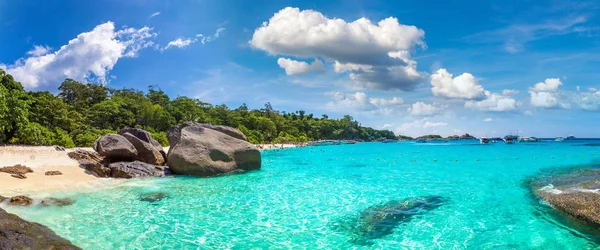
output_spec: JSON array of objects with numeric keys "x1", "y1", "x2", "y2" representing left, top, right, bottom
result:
[{"x1": 93, "y1": 134, "x2": 138, "y2": 161}]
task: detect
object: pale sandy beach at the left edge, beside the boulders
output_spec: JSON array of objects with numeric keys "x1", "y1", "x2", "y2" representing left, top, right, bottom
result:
[{"x1": 0, "y1": 146, "x2": 106, "y2": 196}]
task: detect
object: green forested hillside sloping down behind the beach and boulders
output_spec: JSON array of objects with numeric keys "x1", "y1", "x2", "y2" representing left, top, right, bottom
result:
[{"x1": 0, "y1": 69, "x2": 395, "y2": 147}]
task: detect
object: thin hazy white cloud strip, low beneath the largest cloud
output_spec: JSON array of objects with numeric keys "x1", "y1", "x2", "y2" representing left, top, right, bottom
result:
[{"x1": 326, "y1": 92, "x2": 404, "y2": 114}]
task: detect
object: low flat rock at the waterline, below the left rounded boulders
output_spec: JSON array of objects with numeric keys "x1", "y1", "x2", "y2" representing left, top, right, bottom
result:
[{"x1": 108, "y1": 161, "x2": 165, "y2": 179}]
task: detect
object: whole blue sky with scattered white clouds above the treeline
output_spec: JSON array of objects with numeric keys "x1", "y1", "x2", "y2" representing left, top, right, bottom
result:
[{"x1": 0, "y1": 0, "x2": 600, "y2": 137}]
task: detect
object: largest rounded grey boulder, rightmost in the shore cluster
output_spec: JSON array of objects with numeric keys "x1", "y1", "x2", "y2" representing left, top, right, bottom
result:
[{"x1": 167, "y1": 122, "x2": 261, "y2": 177}]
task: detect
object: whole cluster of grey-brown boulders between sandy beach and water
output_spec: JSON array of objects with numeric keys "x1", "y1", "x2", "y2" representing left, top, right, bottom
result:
[{"x1": 69, "y1": 122, "x2": 261, "y2": 178}]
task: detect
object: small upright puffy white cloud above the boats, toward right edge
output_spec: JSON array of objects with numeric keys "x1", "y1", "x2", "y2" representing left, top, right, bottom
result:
[{"x1": 529, "y1": 78, "x2": 570, "y2": 108}]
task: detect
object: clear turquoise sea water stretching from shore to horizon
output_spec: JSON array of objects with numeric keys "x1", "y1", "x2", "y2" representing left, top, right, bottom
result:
[{"x1": 6, "y1": 140, "x2": 600, "y2": 249}]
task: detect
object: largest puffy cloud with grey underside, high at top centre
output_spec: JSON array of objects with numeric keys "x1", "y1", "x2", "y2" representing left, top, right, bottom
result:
[{"x1": 249, "y1": 7, "x2": 425, "y2": 90}]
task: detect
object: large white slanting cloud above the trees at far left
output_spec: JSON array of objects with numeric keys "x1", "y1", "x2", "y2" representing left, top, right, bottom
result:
[{"x1": 3, "y1": 22, "x2": 156, "y2": 89}]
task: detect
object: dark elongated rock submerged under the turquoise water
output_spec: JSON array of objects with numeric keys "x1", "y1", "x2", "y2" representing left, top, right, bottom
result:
[{"x1": 342, "y1": 196, "x2": 447, "y2": 245}]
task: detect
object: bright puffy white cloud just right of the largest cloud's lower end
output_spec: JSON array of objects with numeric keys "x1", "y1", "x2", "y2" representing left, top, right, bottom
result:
[{"x1": 430, "y1": 69, "x2": 485, "y2": 99}]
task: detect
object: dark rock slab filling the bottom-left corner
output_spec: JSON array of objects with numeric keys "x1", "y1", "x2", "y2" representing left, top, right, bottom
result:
[{"x1": 0, "y1": 208, "x2": 80, "y2": 250}]
